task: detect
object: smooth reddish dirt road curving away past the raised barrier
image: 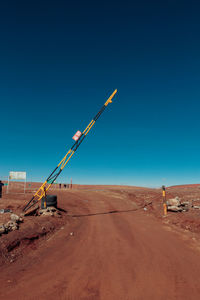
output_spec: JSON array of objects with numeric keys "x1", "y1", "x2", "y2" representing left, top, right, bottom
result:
[{"x1": 0, "y1": 191, "x2": 200, "y2": 300}]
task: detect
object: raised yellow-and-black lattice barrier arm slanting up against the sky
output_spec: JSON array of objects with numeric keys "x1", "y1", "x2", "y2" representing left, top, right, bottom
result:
[{"x1": 23, "y1": 90, "x2": 117, "y2": 212}]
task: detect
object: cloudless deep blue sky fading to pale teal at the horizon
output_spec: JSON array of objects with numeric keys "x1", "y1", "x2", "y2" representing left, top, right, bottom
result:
[{"x1": 0, "y1": 0, "x2": 200, "y2": 186}]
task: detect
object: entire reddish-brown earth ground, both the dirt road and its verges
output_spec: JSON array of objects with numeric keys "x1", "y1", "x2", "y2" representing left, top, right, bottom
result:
[{"x1": 0, "y1": 185, "x2": 200, "y2": 300}]
